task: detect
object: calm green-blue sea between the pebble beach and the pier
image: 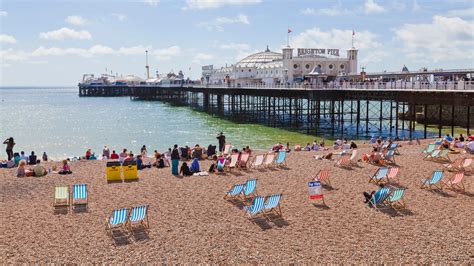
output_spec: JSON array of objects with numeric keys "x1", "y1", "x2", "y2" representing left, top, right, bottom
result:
[{"x1": 0, "y1": 87, "x2": 315, "y2": 160}]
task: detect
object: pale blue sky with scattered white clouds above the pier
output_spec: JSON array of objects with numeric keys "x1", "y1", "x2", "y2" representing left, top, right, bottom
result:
[{"x1": 0, "y1": 0, "x2": 474, "y2": 86}]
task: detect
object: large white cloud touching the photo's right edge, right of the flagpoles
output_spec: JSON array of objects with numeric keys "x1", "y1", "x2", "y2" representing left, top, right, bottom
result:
[{"x1": 394, "y1": 16, "x2": 474, "y2": 62}]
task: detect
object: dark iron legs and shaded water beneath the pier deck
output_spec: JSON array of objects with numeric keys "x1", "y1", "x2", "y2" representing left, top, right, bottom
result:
[{"x1": 124, "y1": 85, "x2": 474, "y2": 139}]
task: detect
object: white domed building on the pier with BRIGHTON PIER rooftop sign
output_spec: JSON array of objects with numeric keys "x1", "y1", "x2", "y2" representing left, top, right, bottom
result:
[{"x1": 201, "y1": 46, "x2": 358, "y2": 86}]
